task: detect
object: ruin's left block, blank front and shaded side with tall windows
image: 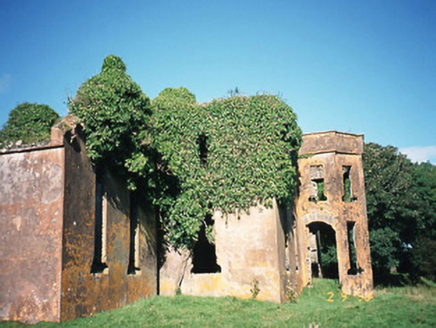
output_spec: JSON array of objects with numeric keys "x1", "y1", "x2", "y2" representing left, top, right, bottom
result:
[{"x1": 0, "y1": 121, "x2": 157, "y2": 323}]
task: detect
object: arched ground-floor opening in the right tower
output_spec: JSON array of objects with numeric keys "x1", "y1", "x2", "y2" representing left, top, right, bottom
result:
[{"x1": 307, "y1": 222, "x2": 339, "y2": 279}]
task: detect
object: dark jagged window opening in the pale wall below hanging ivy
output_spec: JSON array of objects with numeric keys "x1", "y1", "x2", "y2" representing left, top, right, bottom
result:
[{"x1": 191, "y1": 215, "x2": 221, "y2": 273}]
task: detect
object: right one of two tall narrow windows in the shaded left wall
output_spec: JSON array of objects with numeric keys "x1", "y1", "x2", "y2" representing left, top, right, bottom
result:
[{"x1": 127, "y1": 193, "x2": 141, "y2": 275}]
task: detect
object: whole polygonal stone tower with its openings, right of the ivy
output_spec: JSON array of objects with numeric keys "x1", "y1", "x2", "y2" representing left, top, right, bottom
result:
[{"x1": 294, "y1": 131, "x2": 373, "y2": 298}]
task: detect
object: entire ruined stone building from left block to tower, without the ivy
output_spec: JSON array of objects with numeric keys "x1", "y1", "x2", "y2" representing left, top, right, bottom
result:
[{"x1": 0, "y1": 124, "x2": 372, "y2": 322}]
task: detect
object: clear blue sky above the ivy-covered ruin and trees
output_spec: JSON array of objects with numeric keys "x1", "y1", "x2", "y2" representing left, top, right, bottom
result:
[{"x1": 0, "y1": 0, "x2": 436, "y2": 164}]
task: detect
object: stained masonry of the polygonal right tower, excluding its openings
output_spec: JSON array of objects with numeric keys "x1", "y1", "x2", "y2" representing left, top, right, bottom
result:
[{"x1": 296, "y1": 131, "x2": 373, "y2": 298}]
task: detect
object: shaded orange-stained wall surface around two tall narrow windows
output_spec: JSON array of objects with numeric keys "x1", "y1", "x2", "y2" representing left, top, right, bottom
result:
[{"x1": 61, "y1": 130, "x2": 157, "y2": 320}]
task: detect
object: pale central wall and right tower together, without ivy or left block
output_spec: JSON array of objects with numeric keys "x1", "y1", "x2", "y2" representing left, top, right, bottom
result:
[{"x1": 160, "y1": 131, "x2": 372, "y2": 302}]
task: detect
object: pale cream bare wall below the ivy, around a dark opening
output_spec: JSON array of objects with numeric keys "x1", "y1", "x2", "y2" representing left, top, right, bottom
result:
[{"x1": 161, "y1": 201, "x2": 287, "y2": 302}]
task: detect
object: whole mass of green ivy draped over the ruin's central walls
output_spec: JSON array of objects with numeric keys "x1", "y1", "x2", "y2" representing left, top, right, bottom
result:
[{"x1": 70, "y1": 56, "x2": 302, "y2": 248}]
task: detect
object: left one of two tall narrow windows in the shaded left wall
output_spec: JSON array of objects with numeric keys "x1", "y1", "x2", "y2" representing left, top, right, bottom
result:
[{"x1": 91, "y1": 171, "x2": 108, "y2": 274}]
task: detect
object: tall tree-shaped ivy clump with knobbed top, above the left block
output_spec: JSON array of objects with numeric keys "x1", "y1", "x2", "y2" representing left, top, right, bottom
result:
[{"x1": 69, "y1": 56, "x2": 155, "y2": 189}]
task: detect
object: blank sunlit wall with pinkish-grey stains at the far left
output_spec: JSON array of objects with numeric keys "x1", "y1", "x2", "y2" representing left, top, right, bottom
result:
[{"x1": 0, "y1": 146, "x2": 64, "y2": 323}]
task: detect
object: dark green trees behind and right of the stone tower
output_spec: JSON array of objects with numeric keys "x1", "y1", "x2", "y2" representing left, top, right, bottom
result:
[{"x1": 363, "y1": 143, "x2": 436, "y2": 279}]
